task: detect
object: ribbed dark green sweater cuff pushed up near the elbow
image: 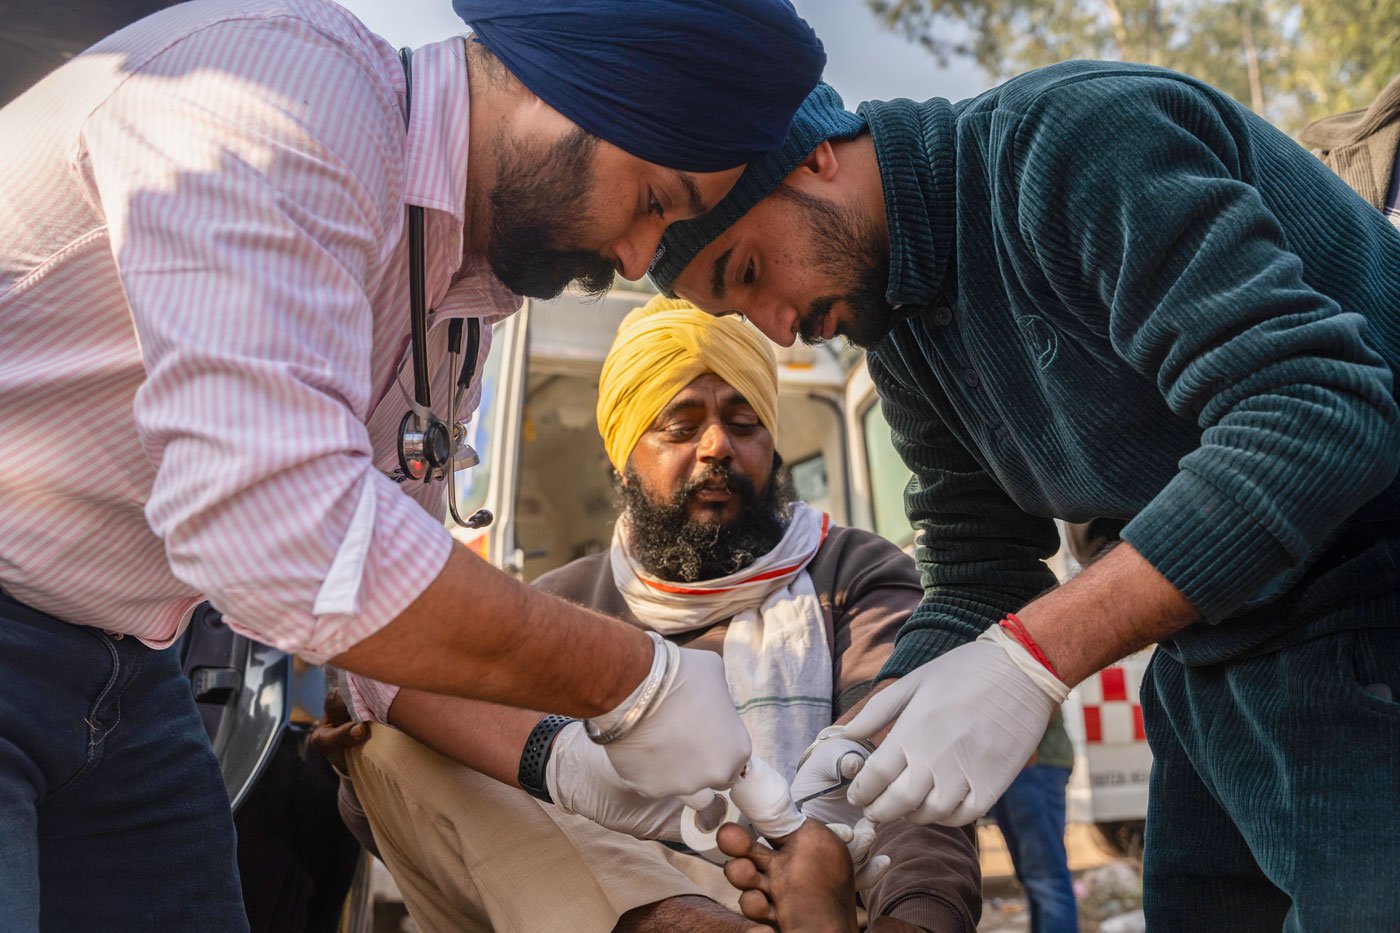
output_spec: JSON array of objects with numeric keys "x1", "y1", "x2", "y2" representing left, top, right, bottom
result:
[{"x1": 1123, "y1": 471, "x2": 1292, "y2": 622}]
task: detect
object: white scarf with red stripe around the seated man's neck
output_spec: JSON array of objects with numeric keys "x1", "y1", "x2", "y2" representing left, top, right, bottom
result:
[{"x1": 609, "y1": 502, "x2": 832, "y2": 783}]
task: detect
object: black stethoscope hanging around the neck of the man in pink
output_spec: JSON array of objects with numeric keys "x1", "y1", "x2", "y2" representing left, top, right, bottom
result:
[{"x1": 399, "y1": 49, "x2": 494, "y2": 528}]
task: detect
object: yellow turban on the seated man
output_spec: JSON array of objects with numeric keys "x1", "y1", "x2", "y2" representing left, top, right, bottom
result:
[{"x1": 598, "y1": 294, "x2": 778, "y2": 472}]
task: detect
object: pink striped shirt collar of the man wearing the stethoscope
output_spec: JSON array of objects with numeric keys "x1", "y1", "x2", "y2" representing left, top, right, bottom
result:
[{"x1": 403, "y1": 36, "x2": 470, "y2": 222}]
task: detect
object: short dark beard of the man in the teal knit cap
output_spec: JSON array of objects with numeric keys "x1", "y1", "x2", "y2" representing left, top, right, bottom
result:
[{"x1": 774, "y1": 185, "x2": 895, "y2": 347}]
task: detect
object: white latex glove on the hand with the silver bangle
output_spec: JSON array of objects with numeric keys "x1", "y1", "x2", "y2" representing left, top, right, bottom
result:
[{"x1": 602, "y1": 642, "x2": 750, "y2": 810}]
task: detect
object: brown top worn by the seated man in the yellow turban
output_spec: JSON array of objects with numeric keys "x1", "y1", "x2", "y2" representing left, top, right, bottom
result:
[{"x1": 535, "y1": 525, "x2": 981, "y2": 933}]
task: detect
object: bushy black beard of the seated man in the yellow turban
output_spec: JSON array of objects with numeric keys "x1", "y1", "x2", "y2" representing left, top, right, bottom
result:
[{"x1": 617, "y1": 454, "x2": 797, "y2": 583}]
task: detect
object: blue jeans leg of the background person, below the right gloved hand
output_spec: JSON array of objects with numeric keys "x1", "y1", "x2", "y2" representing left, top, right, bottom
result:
[{"x1": 991, "y1": 765, "x2": 1079, "y2": 933}]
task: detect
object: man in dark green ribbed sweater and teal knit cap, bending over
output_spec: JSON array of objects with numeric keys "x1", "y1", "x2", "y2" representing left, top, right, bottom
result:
[{"x1": 652, "y1": 62, "x2": 1400, "y2": 930}]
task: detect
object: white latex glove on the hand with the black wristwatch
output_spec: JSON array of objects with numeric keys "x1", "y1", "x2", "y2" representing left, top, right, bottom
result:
[{"x1": 545, "y1": 714, "x2": 682, "y2": 842}]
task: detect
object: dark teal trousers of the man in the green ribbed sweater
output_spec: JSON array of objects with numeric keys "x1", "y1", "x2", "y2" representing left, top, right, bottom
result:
[{"x1": 1142, "y1": 624, "x2": 1400, "y2": 933}]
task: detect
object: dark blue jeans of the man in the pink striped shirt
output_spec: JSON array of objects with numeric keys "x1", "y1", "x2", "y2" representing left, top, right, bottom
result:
[{"x1": 0, "y1": 594, "x2": 248, "y2": 933}]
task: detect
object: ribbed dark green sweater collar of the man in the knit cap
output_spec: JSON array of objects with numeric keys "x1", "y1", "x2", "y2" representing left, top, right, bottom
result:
[{"x1": 860, "y1": 98, "x2": 956, "y2": 308}]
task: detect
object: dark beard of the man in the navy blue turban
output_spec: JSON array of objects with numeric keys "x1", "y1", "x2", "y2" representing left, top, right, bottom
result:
[{"x1": 486, "y1": 127, "x2": 613, "y2": 298}]
